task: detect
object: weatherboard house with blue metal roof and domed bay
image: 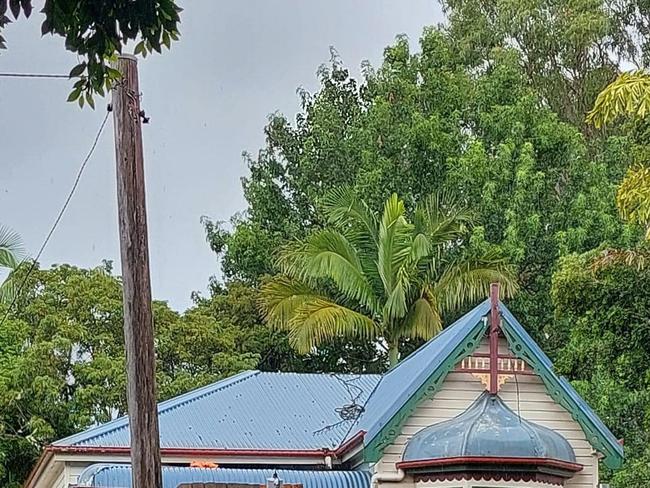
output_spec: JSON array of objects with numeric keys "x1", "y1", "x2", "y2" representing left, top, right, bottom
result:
[{"x1": 26, "y1": 298, "x2": 623, "y2": 488}]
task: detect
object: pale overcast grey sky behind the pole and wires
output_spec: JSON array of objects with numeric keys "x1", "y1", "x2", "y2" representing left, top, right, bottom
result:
[{"x1": 0, "y1": 0, "x2": 442, "y2": 310}]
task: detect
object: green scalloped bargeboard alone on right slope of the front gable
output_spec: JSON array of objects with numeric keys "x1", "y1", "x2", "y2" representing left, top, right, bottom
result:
[{"x1": 501, "y1": 319, "x2": 623, "y2": 469}]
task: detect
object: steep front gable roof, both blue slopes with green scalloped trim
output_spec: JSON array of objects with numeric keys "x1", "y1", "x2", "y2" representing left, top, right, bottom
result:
[{"x1": 359, "y1": 300, "x2": 623, "y2": 469}]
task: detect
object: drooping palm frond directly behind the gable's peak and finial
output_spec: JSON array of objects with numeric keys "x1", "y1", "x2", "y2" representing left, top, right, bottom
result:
[{"x1": 432, "y1": 255, "x2": 518, "y2": 314}]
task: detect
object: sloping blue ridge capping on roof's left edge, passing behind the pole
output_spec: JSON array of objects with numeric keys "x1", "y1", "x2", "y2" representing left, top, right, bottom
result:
[{"x1": 52, "y1": 370, "x2": 260, "y2": 446}]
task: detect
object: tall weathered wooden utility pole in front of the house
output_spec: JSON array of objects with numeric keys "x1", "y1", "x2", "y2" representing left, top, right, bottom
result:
[{"x1": 112, "y1": 55, "x2": 162, "y2": 488}]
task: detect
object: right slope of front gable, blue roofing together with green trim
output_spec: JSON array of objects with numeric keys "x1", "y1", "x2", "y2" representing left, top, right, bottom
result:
[{"x1": 500, "y1": 304, "x2": 624, "y2": 469}]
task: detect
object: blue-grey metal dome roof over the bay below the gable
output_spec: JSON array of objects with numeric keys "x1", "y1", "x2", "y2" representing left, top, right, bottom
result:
[{"x1": 403, "y1": 392, "x2": 576, "y2": 464}]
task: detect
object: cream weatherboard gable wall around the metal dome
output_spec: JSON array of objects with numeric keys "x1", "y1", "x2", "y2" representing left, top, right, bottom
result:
[{"x1": 374, "y1": 339, "x2": 598, "y2": 488}]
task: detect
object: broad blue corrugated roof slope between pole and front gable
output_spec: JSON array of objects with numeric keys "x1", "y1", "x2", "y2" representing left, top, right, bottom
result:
[{"x1": 55, "y1": 371, "x2": 381, "y2": 450}]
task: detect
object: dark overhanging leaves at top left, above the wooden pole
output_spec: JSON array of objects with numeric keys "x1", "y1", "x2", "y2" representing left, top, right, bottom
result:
[{"x1": 0, "y1": 0, "x2": 181, "y2": 106}]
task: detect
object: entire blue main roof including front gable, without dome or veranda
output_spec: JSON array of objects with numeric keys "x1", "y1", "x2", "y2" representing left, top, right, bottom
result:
[{"x1": 54, "y1": 300, "x2": 623, "y2": 468}]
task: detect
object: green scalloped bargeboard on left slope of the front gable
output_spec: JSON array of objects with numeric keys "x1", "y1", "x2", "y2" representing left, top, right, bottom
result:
[{"x1": 363, "y1": 318, "x2": 487, "y2": 463}]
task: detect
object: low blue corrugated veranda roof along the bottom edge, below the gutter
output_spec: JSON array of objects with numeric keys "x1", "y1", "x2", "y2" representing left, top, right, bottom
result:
[{"x1": 78, "y1": 464, "x2": 370, "y2": 488}]
